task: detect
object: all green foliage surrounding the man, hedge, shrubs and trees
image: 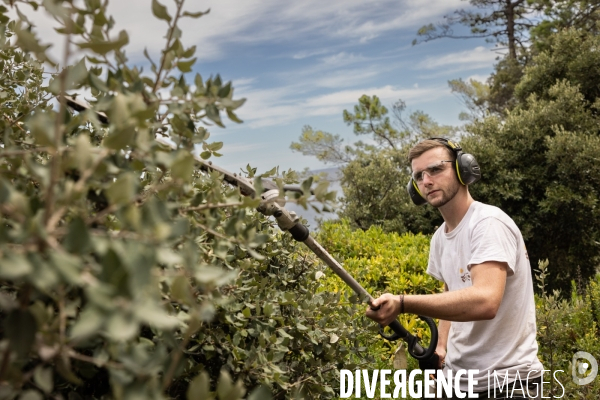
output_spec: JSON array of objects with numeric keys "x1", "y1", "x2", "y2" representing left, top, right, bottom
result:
[{"x1": 0, "y1": 0, "x2": 600, "y2": 400}]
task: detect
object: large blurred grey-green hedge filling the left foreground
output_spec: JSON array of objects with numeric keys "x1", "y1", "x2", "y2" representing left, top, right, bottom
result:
[{"x1": 0, "y1": 0, "x2": 356, "y2": 400}]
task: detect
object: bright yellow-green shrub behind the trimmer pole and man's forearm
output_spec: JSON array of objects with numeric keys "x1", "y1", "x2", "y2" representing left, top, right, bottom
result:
[{"x1": 318, "y1": 220, "x2": 443, "y2": 369}]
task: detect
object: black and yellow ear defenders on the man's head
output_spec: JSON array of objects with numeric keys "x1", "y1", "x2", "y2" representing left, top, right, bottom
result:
[{"x1": 406, "y1": 138, "x2": 481, "y2": 206}]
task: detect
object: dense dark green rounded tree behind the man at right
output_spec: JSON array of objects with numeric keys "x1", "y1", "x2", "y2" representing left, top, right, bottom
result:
[{"x1": 463, "y1": 29, "x2": 600, "y2": 288}]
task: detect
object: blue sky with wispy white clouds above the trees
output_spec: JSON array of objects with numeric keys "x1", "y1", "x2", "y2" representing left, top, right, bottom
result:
[{"x1": 15, "y1": 0, "x2": 498, "y2": 172}]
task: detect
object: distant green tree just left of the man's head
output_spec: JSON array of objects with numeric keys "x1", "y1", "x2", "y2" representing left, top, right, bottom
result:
[{"x1": 291, "y1": 95, "x2": 454, "y2": 233}]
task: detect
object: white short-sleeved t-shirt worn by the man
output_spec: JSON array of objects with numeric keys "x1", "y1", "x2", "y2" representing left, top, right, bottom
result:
[{"x1": 427, "y1": 202, "x2": 543, "y2": 391}]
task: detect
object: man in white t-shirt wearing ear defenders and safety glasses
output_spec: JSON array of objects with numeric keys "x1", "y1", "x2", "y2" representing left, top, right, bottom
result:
[{"x1": 367, "y1": 138, "x2": 543, "y2": 398}]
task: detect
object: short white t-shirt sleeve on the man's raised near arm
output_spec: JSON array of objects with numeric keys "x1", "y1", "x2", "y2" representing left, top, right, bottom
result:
[{"x1": 468, "y1": 217, "x2": 518, "y2": 276}]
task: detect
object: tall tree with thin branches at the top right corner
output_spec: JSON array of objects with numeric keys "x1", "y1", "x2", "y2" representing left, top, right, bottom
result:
[{"x1": 428, "y1": 0, "x2": 600, "y2": 121}]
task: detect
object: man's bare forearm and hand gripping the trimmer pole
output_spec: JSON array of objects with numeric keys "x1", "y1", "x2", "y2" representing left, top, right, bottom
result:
[{"x1": 367, "y1": 261, "x2": 508, "y2": 328}]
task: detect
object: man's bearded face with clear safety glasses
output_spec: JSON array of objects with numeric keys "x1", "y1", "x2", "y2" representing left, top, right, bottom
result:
[{"x1": 411, "y1": 147, "x2": 460, "y2": 208}]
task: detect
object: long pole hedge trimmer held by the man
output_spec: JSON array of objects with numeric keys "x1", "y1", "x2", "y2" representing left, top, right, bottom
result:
[{"x1": 64, "y1": 96, "x2": 439, "y2": 370}]
